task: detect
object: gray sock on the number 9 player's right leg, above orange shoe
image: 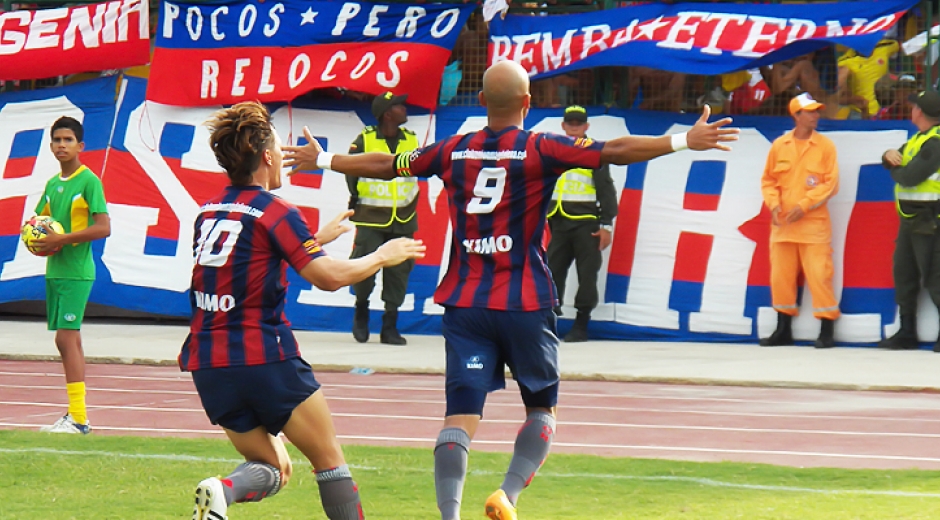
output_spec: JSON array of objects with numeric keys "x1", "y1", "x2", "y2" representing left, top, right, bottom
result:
[{"x1": 500, "y1": 412, "x2": 555, "y2": 505}]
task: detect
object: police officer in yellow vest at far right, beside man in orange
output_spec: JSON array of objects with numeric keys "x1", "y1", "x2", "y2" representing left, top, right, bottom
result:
[{"x1": 878, "y1": 90, "x2": 940, "y2": 352}]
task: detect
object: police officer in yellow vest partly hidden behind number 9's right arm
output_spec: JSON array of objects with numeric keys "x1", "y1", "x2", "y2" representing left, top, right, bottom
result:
[{"x1": 548, "y1": 106, "x2": 617, "y2": 342}]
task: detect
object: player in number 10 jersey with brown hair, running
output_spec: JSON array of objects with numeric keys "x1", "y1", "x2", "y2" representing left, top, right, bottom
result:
[{"x1": 179, "y1": 103, "x2": 425, "y2": 520}]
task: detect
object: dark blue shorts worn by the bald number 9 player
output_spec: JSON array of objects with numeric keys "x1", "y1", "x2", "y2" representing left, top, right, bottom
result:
[{"x1": 443, "y1": 307, "x2": 560, "y2": 415}]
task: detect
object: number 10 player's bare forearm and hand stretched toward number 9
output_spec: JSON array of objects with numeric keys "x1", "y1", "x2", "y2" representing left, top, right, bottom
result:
[{"x1": 300, "y1": 238, "x2": 427, "y2": 291}]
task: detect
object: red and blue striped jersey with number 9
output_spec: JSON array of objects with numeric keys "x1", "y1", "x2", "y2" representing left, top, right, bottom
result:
[{"x1": 395, "y1": 127, "x2": 604, "y2": 311}]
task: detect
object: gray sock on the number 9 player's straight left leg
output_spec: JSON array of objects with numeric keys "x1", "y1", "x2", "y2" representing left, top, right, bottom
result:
[{"x1": 434, "y1": 428, "x2": 470, "y2": 520}]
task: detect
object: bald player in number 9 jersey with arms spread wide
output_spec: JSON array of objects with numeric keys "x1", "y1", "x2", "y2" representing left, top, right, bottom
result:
[{"x1": 284, "y1": 61, "x2": 738, "y2": 520}]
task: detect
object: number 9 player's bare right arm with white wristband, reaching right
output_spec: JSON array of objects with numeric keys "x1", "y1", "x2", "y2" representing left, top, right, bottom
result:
[{"x1": 601, "y1": 105, "x2": 740, "y2": 165}]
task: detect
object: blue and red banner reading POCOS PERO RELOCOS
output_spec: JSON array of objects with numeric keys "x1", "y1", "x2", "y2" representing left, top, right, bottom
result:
[{"x1": 147, "y1": 0, "x2": 475, "y2": 108}]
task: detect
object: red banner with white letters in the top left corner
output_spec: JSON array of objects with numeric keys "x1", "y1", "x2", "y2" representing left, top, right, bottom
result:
[{"x1": 0, "y1": 0, "x2": 150, "y2": 80}]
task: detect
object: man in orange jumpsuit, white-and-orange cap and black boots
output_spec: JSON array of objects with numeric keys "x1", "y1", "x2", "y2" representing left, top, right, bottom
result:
[{"x1": 760, "y1": 94, "x2": 840, "y2": 348}]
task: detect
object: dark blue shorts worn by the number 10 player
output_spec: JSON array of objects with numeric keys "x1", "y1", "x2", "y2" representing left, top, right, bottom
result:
[{"x1": 193, "y1": 357, "x2": 320, "y2": 435}]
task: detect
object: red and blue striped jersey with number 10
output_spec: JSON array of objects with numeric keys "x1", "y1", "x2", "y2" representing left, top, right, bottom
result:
[{"x1": 179, "y1": 186, "x2": 325, "y2": 370}]
